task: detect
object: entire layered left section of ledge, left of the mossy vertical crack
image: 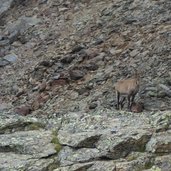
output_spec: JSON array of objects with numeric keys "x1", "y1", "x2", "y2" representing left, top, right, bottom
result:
[{"x1": 0, "y1": 114, "x2": 58, "y2": 171}]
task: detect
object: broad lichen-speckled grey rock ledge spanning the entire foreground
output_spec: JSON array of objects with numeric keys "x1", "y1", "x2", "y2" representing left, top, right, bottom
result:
[{"x1": 0, "y1": 111, "x2": 171, "y2": 171}]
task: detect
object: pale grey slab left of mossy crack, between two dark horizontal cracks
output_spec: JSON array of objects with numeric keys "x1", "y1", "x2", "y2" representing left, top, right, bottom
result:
[{"x1": 0, "y1": 130, "x2": 56, "y2": 158}]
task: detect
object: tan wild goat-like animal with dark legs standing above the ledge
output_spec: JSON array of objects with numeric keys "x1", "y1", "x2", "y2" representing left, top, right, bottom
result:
[{"x1": 114, "y1": 72, "x2": 140, "y2": 110}]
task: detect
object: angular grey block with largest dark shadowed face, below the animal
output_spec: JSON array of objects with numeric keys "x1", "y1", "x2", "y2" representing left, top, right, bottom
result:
[{"x1": 96, "y1": 128, "x2": 151, "y2": 159}]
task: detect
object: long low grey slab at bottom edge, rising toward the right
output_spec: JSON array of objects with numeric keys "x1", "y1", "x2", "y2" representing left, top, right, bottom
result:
[{"x1": 55, "y1": 153, "x2": 153, "y2": 171}]
